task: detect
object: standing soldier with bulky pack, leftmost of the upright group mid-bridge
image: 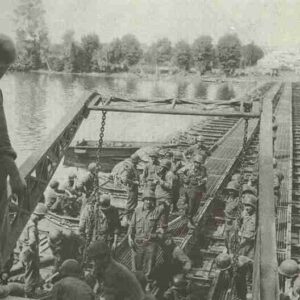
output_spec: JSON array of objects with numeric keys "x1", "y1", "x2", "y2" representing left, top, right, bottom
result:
[{"x1": 121, "y1": 153, "x2": 140, "y2": 222}]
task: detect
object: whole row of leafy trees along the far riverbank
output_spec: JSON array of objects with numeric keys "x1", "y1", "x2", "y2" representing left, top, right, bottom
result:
[{"x1": 13, "y1": 0, "x2": 264, "y2": 75}]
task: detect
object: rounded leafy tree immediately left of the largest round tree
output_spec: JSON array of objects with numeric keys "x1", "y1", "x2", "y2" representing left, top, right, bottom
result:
[{"x1": 192, "y1": 35, "x2": 214, "y2": 74}]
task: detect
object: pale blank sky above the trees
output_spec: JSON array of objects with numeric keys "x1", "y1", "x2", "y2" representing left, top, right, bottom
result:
[{"x1": 0, "y1": 0, "x2": 300, "y2": 48}]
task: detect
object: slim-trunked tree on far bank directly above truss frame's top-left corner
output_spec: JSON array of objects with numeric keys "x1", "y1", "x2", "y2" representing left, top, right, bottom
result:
[{"x1": 81, "y1": 34, "x2": 100, "y2": 72}]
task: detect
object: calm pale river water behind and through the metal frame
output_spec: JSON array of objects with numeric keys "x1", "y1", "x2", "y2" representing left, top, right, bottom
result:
[{"x1": 0, "y1": 73, "x2": 253, "y2": 165}]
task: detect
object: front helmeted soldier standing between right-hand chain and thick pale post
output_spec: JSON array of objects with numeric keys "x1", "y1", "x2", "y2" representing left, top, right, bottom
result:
[{"x1": 239, "y1": 194, "x2": 257, "y2": 259}]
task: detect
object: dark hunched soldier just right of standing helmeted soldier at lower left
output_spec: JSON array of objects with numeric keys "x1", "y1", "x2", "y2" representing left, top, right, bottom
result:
[{"x1": 49, "y1": 230, "x2": 84, "y2": 273}]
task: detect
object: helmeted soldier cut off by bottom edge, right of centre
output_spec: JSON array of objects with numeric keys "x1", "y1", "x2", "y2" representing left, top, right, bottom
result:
[{"x1": 163, "y1": 274, "x2": 191, "y2": 300}]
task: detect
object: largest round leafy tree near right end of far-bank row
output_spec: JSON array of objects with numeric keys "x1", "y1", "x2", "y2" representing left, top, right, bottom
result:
[{"x1": 217, "y1": 34, "x2": 242, "y2": 75}]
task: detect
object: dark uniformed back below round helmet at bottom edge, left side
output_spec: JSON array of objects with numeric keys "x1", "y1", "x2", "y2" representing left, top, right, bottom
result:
[{"x1": 51, "y1": 276, "x2": 96, "y2": 300}]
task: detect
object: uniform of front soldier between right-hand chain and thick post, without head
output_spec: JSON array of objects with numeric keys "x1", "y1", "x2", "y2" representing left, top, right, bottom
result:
[{"x1": 239, "y1": 213, "x2": 256, "y2": 259}]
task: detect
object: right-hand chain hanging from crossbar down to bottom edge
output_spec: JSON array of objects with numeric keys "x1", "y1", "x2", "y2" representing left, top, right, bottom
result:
[{"x1": 232, "y1": 119, "x2": 249, "y2": 300}]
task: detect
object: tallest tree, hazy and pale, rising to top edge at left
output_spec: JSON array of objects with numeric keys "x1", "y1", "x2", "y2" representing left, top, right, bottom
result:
[{"x1": 14, "y1": 0, "x2": 49, "y2": 69}]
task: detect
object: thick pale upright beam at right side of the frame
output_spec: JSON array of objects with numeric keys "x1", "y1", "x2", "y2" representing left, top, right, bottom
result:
[{"x1": 253, "y1": 87, "x2": 279, "y2": 300}]
